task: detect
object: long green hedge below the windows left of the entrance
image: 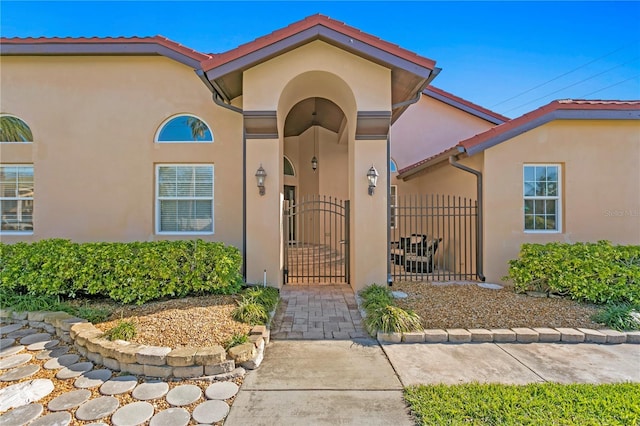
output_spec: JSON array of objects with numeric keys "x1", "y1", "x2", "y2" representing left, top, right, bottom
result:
[{"x1": 0, "y1": 239, "x2": 242, "y2": 304}]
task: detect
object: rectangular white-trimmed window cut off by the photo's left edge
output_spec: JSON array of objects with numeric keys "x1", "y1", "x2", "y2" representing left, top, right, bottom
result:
[{"x1": 0, "y1": 164, "x2": 33, "y2": 233}]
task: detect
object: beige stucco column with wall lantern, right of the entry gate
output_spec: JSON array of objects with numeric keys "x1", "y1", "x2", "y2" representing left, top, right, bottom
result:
[{"x1": 349, "y1": 111, "x2": 390, "y2": 292}]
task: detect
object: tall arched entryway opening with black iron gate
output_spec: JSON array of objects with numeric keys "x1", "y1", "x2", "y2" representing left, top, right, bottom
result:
[{"x1": 283, "y1": 96, "x2": 350, "y2": 284}]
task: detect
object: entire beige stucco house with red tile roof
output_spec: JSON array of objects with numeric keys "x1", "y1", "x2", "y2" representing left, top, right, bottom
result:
[{"x1": 0, "y1": 15, "x2": 640, "y2": 290}]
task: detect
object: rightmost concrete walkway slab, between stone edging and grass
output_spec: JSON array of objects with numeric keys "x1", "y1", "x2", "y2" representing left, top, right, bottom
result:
[{"x1": 498, "y1": 343, "x2": 640, "y2": 383}]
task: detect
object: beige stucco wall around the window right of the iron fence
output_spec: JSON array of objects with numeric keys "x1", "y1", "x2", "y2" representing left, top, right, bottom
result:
[{"x1": 484, "y1": 120, "x2": 640, "y2": 281}]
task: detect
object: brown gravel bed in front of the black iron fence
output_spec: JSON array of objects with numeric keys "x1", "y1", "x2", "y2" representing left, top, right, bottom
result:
[{"x1": 392, "y1": 282, "x2": 604, "y2": 329}]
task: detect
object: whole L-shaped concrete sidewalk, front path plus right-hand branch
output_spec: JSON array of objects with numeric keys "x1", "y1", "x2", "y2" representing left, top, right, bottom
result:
[{"x1": 225, "y1": 339, "x2": 640, "y2": 426}]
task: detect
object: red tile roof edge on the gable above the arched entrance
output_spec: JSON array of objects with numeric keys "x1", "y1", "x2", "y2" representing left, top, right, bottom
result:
[{"x1": 202, "y1": 14, "x2": 435, "y2": 71}]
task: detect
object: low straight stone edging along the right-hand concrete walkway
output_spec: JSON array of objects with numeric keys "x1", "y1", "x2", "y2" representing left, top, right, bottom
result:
[{"x1": 376, "y1": 327, "x2": 640, "y2": 345}]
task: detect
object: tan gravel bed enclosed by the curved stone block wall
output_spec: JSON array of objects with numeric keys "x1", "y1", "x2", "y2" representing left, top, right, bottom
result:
[{"x1": 94, "y1": 295, "x2": 251, "y2": 349}]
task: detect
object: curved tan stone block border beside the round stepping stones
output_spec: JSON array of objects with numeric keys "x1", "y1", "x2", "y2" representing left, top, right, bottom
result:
[{"x1": 0, "y1": 310, "x2": 270, "y2": 379}]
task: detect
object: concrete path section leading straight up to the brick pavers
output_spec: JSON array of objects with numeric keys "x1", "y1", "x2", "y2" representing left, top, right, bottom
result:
[{"x1": 225, "y1": 339, "x2": 414, "y2": 426}]
